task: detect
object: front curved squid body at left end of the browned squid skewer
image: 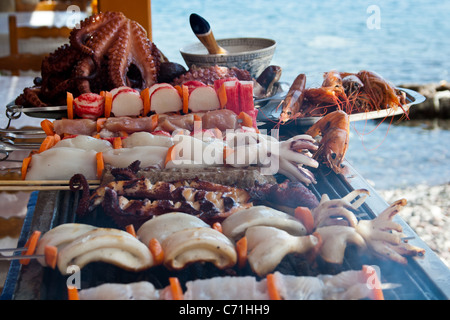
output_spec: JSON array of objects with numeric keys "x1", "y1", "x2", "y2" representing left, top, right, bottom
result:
[{"x1": 57, "y1": 228, "x2": 154, "y2": 274}]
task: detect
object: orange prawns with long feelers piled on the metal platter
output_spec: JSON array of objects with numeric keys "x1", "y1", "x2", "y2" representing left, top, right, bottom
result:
[{"x1": 280, "y1": 70, "x2": 406, "y2": 124}]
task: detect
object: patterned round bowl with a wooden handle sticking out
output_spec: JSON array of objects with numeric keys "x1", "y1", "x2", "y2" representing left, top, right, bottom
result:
[{"x1": 180, "y1": 38, "x2": 276, "y2": 78}]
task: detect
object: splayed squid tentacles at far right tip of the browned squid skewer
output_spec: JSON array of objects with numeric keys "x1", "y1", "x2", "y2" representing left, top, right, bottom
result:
[{"x1": 356, "y1": 199, "x2": 425, "y2": 264}]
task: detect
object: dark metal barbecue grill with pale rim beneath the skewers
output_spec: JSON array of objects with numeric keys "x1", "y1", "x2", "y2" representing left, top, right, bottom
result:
[{"x1": 2, "y1": 161, "x2": 450, "y2": 300}]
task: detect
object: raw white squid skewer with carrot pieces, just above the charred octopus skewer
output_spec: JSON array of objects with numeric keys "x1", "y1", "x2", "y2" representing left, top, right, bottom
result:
[{"x1": 22, "y1": 124, "x2": 318, "y2": 184}]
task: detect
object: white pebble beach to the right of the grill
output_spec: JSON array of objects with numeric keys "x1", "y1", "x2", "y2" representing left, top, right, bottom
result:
[{"x1": 378, "y1": 182, "x2": 450, "y2": 267}]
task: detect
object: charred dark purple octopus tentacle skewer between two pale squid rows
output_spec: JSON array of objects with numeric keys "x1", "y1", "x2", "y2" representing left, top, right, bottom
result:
[{"x1": 90, "y1": 179, "x2": 252, "y2": 228}]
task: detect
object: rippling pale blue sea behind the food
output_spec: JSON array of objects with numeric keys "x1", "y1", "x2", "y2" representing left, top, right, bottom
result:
[{"x1": 152, "y1": 0, "x2": 450, "y2": 189}]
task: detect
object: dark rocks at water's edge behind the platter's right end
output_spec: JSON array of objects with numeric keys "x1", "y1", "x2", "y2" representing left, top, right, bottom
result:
[{"x1": 398, "y1": 81, "x2": 450, "y2": 119}]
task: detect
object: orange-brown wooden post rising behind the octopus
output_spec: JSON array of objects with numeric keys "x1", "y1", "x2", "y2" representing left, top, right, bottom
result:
[{"x1": 98, "y1": 0, "x2": 152, "y2": 41}]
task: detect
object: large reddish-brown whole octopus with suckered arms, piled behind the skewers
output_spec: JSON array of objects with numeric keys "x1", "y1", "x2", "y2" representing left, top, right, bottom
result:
[{"x1": 15, "y1": 12, "x2": 251, "y2": 107}]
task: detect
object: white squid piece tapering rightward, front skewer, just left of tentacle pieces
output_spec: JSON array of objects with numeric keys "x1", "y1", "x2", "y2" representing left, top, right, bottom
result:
[{"x1": 245, "y1": 226, "x2": 320, "y2": 276}]
